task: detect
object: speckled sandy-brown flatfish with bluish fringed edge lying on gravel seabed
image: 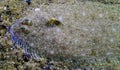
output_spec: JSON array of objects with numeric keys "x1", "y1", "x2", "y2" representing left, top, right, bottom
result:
[{"x1": 10, "y1": 1, "x2": 120, "y2": 66}]
